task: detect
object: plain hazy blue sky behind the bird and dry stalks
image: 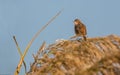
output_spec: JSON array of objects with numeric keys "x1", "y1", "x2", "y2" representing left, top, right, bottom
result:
[{"x1": 0, "y1": 0, "x2": 120, "y2": 75}]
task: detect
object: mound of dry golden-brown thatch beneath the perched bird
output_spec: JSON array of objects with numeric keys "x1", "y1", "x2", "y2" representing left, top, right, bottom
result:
[{"x1": 27, "y1": 35, "x2": 120, "y2": 75}]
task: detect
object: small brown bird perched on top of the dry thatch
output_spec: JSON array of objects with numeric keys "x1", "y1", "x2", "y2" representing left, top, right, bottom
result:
[{"x1": 72, "y1": 19, "x2": 87, "y2": 41}]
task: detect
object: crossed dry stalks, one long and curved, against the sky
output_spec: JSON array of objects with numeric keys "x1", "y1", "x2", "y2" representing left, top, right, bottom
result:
[{"x1": 13, "y1": 9, "x2": 63, "y2": 75}]
